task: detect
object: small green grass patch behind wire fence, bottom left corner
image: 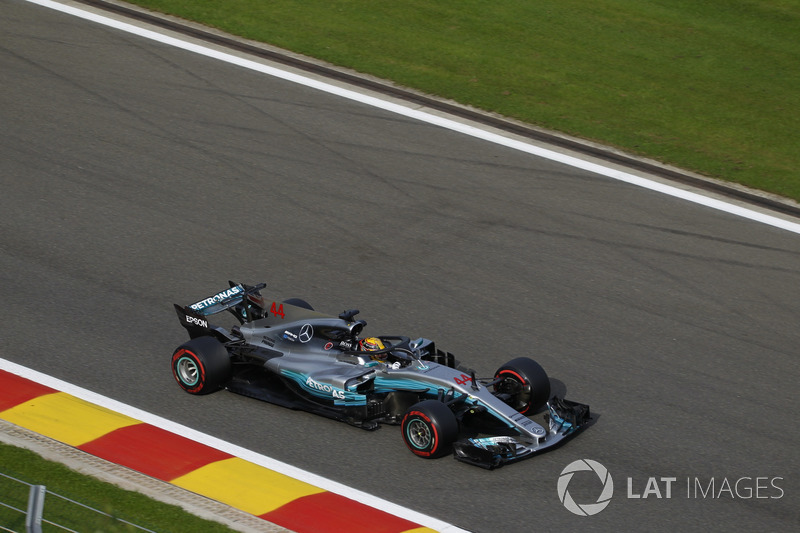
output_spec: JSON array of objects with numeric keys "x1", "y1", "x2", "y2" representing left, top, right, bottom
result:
[{"x1": 0, "y1": 443, "x2": 232, "y2": 533}]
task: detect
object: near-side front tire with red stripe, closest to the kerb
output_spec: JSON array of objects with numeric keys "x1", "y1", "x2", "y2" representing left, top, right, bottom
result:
[{"x1": 400, "y1": 400, "x2": 458, "y2": 459}]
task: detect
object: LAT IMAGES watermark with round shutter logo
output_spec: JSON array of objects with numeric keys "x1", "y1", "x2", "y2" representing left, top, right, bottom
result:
[{"x1": 556, "y1": 459, "x2": 786, "y2": 516}]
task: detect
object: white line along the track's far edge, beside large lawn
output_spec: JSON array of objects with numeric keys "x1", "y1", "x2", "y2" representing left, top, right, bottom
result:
[{"x1": 27, "y1": 0, "x2": 800, "y2": 234}]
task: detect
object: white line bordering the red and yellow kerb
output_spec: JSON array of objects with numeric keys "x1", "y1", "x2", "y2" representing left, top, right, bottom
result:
[{"x1": 0, "y1": 358, "x2": 467, "y2": 533}]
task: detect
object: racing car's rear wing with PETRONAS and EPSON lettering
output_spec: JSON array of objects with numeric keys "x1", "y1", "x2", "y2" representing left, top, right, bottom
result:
[{"x1": 175, "y1": 281, "x2": 266, "y2": 338}]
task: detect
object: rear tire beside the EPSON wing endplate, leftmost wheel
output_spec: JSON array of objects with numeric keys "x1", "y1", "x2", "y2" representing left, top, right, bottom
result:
[{"x1": 172, "y1": 337, "x2": 231, "y2": 394}]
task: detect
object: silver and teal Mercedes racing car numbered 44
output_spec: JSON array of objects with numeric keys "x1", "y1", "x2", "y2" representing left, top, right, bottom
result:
[{"x1": 172, "y1": 281, "x2": 591, "y2": 469}]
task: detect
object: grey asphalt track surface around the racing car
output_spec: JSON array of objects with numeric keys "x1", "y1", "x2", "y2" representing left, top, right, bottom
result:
[{"x1": 0, "y1": 0, "x2": 800, "y2": 532}]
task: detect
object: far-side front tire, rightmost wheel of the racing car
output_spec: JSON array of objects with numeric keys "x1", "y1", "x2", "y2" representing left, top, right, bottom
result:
[{"x1": 494, "y1": 357, "x2": 550, "y2": 415}]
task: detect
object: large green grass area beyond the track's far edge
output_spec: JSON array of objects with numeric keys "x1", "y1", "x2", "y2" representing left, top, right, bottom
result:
[{"x1": 122, "y1": 0, "x2": 800, "y2": 200}]
